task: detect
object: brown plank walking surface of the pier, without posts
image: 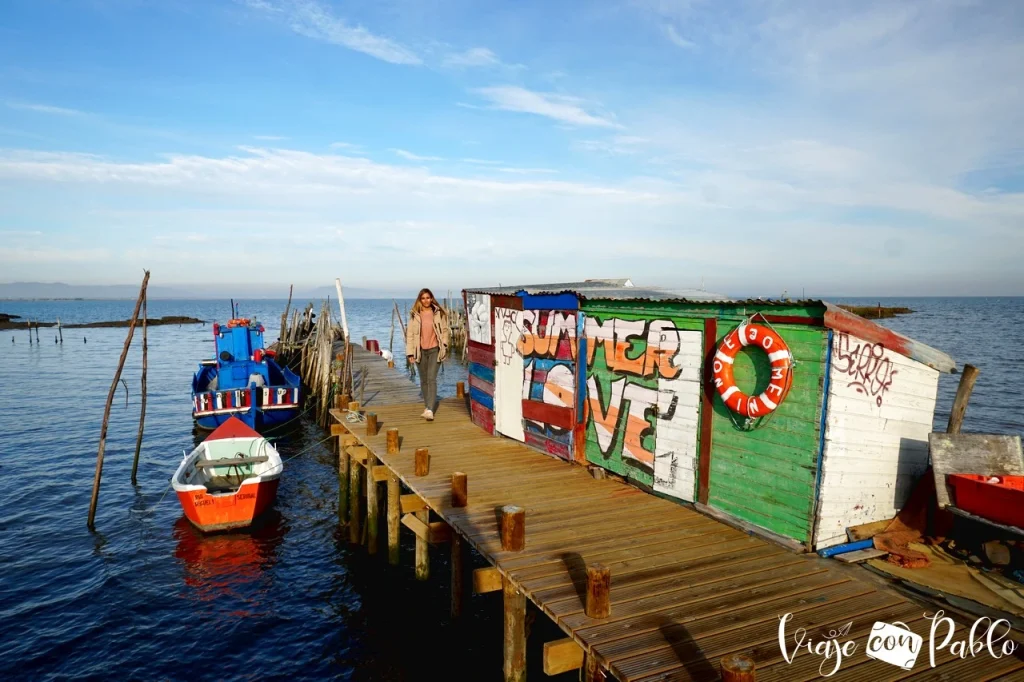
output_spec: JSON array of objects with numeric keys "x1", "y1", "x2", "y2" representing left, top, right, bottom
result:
[{"x1": 332, "y1": 353, "x2": 1024, "y2": 682}]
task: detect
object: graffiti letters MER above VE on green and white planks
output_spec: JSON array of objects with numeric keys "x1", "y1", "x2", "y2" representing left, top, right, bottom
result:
[{"x1": 586, "y1": 315, "x2": 702, "y2": 500}]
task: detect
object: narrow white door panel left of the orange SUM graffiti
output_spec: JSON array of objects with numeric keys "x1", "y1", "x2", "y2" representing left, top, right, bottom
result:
[{"x1": 495, "y1": 307, "x2": 526, "y2": 442}]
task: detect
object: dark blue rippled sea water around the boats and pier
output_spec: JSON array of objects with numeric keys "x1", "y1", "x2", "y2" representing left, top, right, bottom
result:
[{"x1": 0, "y1": 298, "x2": 1024, "y2": 680}]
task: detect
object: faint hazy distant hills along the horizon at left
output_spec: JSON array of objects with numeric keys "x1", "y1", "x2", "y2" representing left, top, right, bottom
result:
[{"x1": 0, "y1": 282, "x2": 416, "y2": 300}]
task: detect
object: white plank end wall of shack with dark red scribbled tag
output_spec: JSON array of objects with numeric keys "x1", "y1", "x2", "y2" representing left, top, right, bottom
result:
[{"x1": 811, "y1": 333, "x2": 939, "y2": 549}]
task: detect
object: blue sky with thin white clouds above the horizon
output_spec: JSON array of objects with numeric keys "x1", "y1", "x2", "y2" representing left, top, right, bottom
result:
[{"x1": 0, "y1": 0, "x2": 1024, "y2": 296}]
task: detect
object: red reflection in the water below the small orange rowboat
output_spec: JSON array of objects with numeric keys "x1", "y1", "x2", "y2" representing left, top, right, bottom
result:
[{"x1": 172, "y1": 509, "x2": 288, "y2": 601}]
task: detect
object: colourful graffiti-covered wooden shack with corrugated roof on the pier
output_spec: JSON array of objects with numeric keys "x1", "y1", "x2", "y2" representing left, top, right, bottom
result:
[{"x1": 463, "y1": 280, "x2": 955, "y2": 550}]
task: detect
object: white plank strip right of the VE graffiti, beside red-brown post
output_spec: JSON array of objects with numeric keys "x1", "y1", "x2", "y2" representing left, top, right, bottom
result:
[{"x1": 647, "y1": 329, "x2": 703, "y2": 502}]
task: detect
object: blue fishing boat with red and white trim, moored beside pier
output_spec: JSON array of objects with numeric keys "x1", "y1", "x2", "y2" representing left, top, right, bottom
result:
[{"x1": 193, "y1": 315, "x2": 302, "y2": 431}]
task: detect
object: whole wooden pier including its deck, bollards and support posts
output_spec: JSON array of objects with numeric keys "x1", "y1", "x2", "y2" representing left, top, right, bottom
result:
[{"x1": 331, "y1": 349, "x2": 1024, "y2": 682}]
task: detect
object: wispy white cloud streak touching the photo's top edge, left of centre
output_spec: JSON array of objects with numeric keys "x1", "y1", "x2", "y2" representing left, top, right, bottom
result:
[{"x1": 243, "y1": 0, "x2": 423, "y2": 66}]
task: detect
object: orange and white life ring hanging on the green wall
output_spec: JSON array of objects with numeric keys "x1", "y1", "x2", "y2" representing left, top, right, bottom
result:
[{"x1": 712, "y1": 323, "x2": 793, "y2": 417}]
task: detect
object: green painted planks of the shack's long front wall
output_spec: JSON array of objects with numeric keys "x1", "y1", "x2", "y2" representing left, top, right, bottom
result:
[{"x1": 582, "y1": 301, "x2": 827, "y2": 542}]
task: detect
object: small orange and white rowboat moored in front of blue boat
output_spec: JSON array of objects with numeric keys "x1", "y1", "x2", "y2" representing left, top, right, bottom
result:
[{"x1": 171, "y1": 417, "x2": 283, "y2": 530}]
